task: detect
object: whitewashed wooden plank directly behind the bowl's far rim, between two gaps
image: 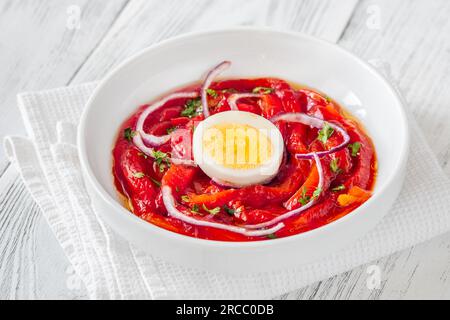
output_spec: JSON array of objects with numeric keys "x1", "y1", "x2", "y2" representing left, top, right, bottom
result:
[{"x1": 74, "y1": 0, "x2": 357, "y2": 82}]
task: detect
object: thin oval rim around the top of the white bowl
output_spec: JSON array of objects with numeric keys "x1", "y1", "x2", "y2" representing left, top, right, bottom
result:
[{"x1": 77, "y1": 27, "x2": 410, "y2": 249}]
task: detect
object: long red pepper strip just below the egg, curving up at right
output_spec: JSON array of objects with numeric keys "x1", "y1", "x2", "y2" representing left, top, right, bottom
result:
[{"x1": 188, "y1": 160, "x2": 309, "y2": 208}]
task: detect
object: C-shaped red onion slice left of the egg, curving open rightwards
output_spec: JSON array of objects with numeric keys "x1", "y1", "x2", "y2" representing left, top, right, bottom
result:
[{"x1": 135, "y1": 92, "x2": 198, "y2": 152}]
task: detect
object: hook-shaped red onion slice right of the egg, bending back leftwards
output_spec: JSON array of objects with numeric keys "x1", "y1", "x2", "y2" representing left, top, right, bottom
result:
[{"x1": 271, "y1": 113, "x2": 350, "y2": 159}]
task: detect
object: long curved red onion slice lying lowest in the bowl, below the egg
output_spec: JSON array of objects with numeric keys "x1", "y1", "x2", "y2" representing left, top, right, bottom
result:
[{"x1": 162, "y1": 186, "x2": 284, "y2": 237}]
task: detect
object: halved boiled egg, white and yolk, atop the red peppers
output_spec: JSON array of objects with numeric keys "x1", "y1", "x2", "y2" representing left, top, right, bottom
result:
[{"x1": 193, "y1": 111, "x2": 284, "y2": 188}]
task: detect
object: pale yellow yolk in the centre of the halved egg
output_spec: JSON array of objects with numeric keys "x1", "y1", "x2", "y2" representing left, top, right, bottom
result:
[{"x1": 202, "y1": 123, "x2": 273, "y2": 170}]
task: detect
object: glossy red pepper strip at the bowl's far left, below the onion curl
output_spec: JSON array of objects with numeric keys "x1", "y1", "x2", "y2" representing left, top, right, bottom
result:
[{"x1": 114, "y1": 141, "x2": 157, "y2": 216}]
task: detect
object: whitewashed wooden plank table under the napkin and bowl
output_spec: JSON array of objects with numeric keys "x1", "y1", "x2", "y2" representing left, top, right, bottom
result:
[{"x1": 0, "y1": 0, "x2": 450, "y2": 299}]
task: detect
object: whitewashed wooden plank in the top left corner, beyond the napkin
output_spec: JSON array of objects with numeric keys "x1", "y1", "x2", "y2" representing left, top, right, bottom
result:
[{"x1": 0, "y1": 0, "x2": 127, "y2": 172}]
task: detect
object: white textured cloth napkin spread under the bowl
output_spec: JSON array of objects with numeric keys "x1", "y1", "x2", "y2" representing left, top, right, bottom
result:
[{"x1": 5, "y1": 83, "x2": 450, "y2": 299}]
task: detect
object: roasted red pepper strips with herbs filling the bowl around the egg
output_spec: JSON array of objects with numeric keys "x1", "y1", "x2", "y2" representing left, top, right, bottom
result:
[{"x1": 113, "y1": 78, "x2": 376, "y2": 241}]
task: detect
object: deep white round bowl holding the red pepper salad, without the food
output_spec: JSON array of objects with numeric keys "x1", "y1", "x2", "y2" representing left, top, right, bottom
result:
[{"x1": 78, "y1": 28, "x2": 409, "y2": 274}]
